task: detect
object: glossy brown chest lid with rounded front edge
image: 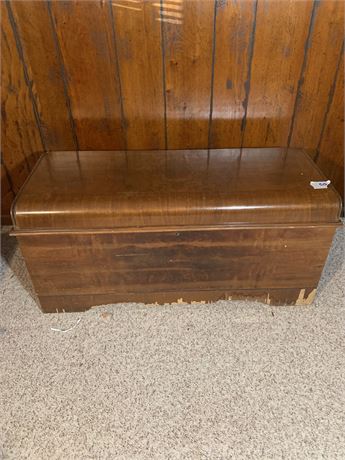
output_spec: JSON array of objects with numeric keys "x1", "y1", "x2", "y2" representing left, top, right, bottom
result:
[{"x1": 12, "y1": 148, "x2": 341, "y2": 230}]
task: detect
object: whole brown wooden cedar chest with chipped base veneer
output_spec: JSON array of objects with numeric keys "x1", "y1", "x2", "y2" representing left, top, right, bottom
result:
[{"x1": 12, "y1": 149, "x2": 341, "y2": 312}]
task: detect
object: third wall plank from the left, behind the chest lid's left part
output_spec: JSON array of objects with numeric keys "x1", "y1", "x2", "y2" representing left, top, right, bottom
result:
[{"x1": 48, "y1": 0, "x2": 125, "y2": 150}]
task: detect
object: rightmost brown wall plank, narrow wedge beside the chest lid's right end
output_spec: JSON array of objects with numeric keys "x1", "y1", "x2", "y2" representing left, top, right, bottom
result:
[{"x1": 317, "y1": 55, "x2": 344, "y2": 196}]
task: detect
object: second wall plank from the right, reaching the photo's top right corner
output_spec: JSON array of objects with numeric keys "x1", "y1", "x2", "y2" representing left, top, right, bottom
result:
[{"x1": 290, "y1": 0, "x2": 344, "y2": 149}]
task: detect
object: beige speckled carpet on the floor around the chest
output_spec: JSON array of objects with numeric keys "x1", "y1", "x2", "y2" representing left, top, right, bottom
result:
[{"x1": 0, "y1": 225, "x2": 345, "y2": 460}]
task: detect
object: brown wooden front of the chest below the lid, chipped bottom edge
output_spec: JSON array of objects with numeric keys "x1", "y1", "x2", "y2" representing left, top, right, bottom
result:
[{"x1": 19, "y1": 225, "x2": 335, "y2": 311}]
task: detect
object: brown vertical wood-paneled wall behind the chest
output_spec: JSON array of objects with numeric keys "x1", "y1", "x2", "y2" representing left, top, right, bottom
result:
[{"x1": 1, "y1": 0, "x2": 344, "y2": 222}]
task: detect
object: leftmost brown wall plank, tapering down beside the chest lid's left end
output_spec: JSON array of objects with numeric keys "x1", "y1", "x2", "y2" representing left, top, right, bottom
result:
[{"x1": 1, "y1": 2, "x2": 43, "y2": 193}]
